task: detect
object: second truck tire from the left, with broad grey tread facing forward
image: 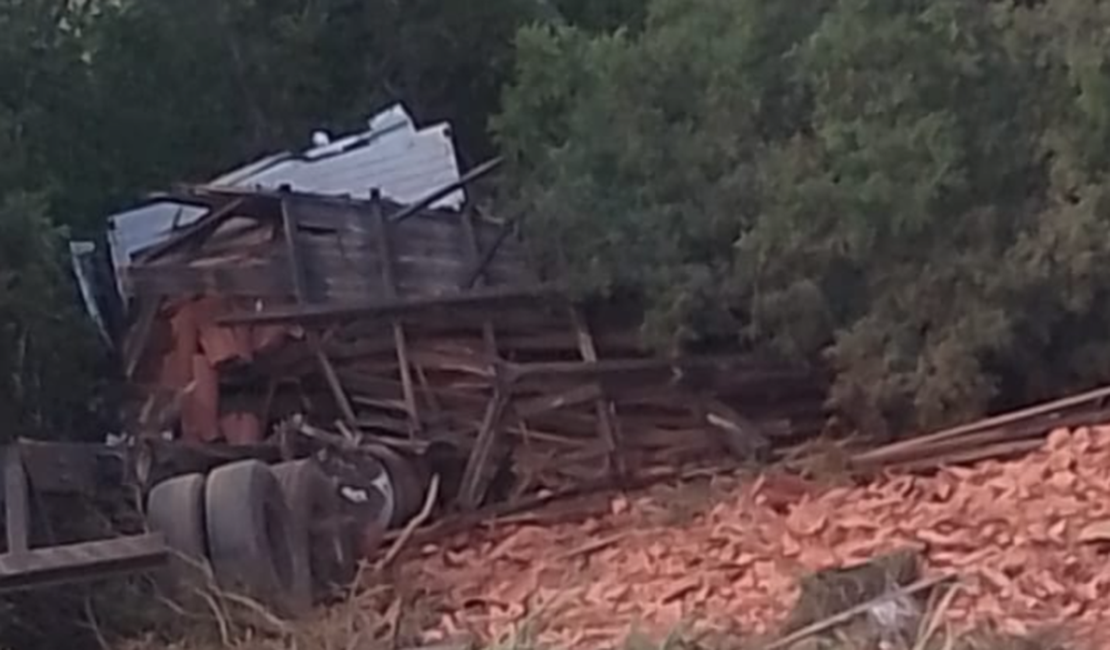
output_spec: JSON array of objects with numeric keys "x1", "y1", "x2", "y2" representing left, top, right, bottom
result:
[{"x1": 204, "y1": 460, "x2": 312, "y2": 617}]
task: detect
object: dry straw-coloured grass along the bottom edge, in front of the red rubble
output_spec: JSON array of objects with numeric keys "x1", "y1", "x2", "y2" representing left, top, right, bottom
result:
[{"x1": 119, "y1": 567, "x2": 1087, "y2": 650}]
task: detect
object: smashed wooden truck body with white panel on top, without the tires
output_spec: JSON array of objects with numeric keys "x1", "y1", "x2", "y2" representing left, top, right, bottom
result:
[{"x1": 84, "y1": 111, "x2": 825, "y2": 520}]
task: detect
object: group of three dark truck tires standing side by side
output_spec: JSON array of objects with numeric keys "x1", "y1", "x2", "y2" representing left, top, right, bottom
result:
[{"x1": 148, "y1": 460, "x2": 356, "y2": 617}]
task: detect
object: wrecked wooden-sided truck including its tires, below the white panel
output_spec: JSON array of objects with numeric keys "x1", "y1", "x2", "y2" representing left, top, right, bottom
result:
[{"x1": 0, "y1": 104, "x2": 824, "y2": 611}]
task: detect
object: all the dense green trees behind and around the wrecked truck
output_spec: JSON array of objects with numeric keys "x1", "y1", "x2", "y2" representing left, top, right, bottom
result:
[{"x1": 0, "y1": 0, "x2": 1110, "y2": 435}]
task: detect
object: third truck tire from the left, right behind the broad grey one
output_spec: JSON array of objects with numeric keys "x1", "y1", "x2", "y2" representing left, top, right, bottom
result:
[{"x1": 273, "y1": 458, "x2": 357, "y2": 598}]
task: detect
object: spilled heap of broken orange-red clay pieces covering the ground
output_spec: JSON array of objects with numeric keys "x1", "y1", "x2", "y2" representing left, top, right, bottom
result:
[{"x1": 404, "y1": 427, "x2": 1110, "y2": 648}]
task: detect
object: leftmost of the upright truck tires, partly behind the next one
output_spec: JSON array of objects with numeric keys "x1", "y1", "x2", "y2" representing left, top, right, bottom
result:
[{"x1": 147, "y1": 474, "x2": 209, "y2": 605}]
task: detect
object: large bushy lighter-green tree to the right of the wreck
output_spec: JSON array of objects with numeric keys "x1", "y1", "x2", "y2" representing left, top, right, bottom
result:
[{"x1": 496, "y1": 0, "x2": 1110, "y2": 429}]
